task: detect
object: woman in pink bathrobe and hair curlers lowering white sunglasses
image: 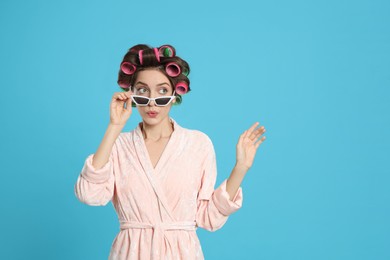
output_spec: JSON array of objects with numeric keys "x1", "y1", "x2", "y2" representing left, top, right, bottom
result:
[{"x1": 75, "y1": 45, "x2": 265, "y2": 259}]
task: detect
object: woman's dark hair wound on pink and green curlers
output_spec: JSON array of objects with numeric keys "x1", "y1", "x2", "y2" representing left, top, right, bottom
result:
[{"x1": 117, "y1": 44, "x2": 190, "y2": 105}]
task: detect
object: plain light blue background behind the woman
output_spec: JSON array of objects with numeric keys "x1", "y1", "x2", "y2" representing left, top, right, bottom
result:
[{"x1": 0, "y1": 0, "x2": 390, "y2": 260}]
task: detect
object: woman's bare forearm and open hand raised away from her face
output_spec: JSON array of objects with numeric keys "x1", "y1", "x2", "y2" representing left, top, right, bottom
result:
[{"x1": 226, "y1": 123, "x2": 265, "y2": 200}]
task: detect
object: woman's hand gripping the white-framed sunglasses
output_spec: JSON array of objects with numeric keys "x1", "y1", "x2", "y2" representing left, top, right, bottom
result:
[{"x1": 110, "y1": 91, "x2": 132, "y2": 126}]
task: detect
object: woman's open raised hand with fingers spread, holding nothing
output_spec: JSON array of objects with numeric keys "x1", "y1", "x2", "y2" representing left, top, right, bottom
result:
[{"x1": 236, "y1": 123, "x2": 265, "y2": 171}]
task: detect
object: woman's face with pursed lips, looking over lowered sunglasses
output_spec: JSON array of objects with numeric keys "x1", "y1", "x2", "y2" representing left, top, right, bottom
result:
[{"x1": 133, "y1": 69, "x2": 175, "y2": 125}]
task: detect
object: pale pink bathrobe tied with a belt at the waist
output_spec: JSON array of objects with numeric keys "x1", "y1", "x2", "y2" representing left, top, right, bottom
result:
[{"x1": 75, "y1": 120, "x2": 242, "y2": 260}]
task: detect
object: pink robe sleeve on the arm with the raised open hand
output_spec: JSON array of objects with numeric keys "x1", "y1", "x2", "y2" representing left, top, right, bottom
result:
[{"x1": 196, "y1": 136, "x2": 242, "y2": 231}]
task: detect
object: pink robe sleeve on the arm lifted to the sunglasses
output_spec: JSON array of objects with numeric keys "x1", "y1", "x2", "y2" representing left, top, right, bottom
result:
[{"x1": 75, "y1": 141, "x2": 117, "y2": 206}]
